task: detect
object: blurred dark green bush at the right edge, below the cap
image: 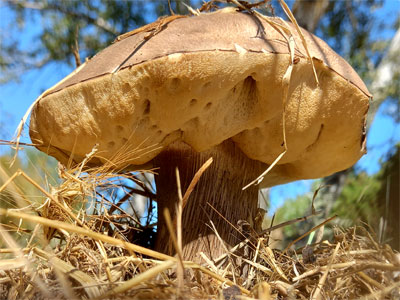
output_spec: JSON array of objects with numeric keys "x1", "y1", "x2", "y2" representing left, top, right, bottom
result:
[{"x1": 333, "y1": 144, "x2": 400, "y2": 249}]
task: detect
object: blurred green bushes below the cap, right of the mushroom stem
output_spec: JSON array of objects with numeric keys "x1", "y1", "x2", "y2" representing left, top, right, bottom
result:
[{"x1": 275, "y1": 144, "x2": 400, "y2": 249}]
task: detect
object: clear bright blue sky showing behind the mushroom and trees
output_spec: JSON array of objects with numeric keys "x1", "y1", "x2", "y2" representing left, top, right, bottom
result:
[{"x1": 0, "y1": 0, "x2": 400, "y2": 210}]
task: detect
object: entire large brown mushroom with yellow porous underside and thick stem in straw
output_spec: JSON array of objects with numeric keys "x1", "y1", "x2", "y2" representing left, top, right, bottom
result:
[{"x1": 30, "y1": 9, "x2": 371, "y2": 260}]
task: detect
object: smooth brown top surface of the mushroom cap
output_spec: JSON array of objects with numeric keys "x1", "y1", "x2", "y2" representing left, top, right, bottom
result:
[{"x1": 51, "y1": 10, "x2": 370, "y2": 95}]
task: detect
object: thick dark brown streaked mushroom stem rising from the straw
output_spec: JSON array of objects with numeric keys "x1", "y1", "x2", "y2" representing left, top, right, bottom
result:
[{"x1": 155, "y1": 140, "x2": 265, "y2": 262}]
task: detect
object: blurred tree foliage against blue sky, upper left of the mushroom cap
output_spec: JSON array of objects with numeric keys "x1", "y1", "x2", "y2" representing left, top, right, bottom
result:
[{"x1": 0, "y1": 0, "x2": 166, "y2": 83}]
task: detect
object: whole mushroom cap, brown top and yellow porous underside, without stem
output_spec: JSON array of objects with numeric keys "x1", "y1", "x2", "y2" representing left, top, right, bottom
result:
[{"x1": 30, "y1": 10, "x2": 370, "y2": 185}]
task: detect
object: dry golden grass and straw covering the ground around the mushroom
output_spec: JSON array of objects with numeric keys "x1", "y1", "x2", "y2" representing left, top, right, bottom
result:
[{"x1": 0, "y1": 150, "x2": 400, "y2": 299}]
